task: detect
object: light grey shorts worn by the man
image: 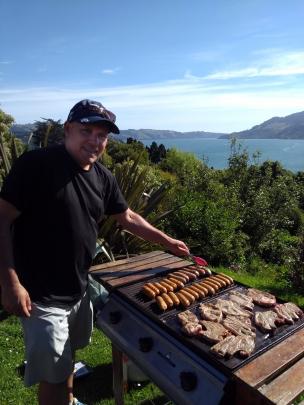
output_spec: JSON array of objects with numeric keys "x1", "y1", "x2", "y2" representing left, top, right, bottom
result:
[{"x1": 20, "y1": 294, "x2": 93, "y2": 386}]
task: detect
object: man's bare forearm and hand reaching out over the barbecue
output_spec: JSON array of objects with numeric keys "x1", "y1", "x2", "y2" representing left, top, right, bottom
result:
[{"x1": 113, "y1": 208, "x2": 189, "y2": 256}]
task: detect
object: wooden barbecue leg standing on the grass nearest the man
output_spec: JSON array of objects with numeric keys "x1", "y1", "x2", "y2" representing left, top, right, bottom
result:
[{"x1": 112, "y1": 343, "x2": 127, "y2": 405}]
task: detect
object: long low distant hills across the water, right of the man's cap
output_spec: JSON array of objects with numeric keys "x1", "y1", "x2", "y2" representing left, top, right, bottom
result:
[{"x1": 119, "y1": 129, "x2": 227, "y2": 141}]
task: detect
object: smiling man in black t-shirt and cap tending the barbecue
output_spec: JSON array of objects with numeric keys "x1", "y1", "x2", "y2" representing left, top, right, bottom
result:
[{"x1": 0, "y1": 100, "x2": 189, "y2": 405}]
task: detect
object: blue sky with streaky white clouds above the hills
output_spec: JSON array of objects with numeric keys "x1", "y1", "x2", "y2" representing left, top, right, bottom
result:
[{"x1": 0, "y1": 0, "x2": 304, "y2": 132}]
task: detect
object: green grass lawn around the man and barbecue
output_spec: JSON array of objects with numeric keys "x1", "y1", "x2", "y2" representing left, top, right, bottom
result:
[{"x1": 0, "y1": 268, "x2": 304, "y2": 405}]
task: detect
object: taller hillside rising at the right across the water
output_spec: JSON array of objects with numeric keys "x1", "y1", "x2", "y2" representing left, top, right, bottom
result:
[{"x1": 221, "y1": 111, "x2": 304, "y2": 139}]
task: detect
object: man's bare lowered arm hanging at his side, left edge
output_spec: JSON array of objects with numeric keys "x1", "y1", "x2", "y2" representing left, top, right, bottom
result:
[{"x1": 0, "y1": 198, "x2": 31, "y2": 316}]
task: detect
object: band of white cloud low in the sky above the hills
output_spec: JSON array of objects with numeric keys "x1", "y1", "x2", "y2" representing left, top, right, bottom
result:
[{"x1": 0, "y1": 51, "x2": 304, "y2": 132}]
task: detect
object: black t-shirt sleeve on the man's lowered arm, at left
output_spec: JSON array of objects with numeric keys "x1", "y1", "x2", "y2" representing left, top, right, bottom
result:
[{"x1": 0, "y1": 152, "x2": 39, "y2": 212}]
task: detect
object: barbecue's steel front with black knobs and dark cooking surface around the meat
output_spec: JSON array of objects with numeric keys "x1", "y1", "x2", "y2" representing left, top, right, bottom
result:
[{"x1": 97, "y1": 274, "x2": 304, "y2": 405}]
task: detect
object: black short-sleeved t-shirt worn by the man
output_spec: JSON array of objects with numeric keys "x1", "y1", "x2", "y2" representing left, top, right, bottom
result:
[{"x1": 0, "y1": 145, "x2": 128, "y2": 306}]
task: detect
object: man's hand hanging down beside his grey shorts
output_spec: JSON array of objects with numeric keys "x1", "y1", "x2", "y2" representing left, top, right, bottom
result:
[{"x1": 1, "y1": 283, "x2": 32, "y2": 317}]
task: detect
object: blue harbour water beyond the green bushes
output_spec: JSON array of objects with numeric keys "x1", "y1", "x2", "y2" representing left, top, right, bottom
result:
[{"x1": 141, "y1": 138, "x2": 304, "y2": 172}]
